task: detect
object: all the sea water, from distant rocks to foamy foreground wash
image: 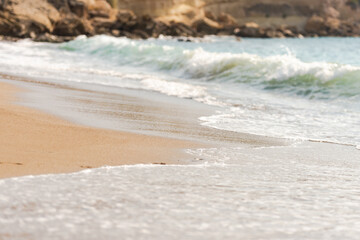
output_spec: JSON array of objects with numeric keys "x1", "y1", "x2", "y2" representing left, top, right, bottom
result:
[{"x1": 0, "y1": 36, "x2": 360, "y2": 239}]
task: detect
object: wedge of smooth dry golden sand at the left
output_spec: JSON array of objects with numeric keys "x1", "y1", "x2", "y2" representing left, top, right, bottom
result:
[{"x1": 0, "y1": 83, "x2": 196, "y2": 178}]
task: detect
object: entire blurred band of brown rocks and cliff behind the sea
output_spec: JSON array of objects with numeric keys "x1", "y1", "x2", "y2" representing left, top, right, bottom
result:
[{"x1": 0, "y1": 0, "x2": 360, "y2": 42}]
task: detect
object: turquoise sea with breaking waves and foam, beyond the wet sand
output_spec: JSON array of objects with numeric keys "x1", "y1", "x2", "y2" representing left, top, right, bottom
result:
[{"x1": 0, "y1": 36, "x2": 360, "y2": 146}]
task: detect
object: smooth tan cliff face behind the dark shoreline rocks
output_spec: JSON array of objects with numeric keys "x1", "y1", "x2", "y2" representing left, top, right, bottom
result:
[{"x1": 118, "y1": 0, "x2": 360, "y2": 29}]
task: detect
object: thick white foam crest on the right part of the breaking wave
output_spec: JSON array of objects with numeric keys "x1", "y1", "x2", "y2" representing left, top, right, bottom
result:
[{"x1": 184, "y1": 48, "x2": 360, "y2": 82}]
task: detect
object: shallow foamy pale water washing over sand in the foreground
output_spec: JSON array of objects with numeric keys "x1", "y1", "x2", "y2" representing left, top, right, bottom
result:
[{"x1": 0, "y1": 144, "x2": 360, "y2": 239}]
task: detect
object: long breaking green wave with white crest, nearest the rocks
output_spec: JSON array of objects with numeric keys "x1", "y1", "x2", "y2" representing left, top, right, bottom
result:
[{"x1": 60, "y1": 36, "x2": 360, "y2": 99}]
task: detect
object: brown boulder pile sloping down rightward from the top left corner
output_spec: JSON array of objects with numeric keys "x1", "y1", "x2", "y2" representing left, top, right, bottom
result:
[{"x1": 0, "y1": 0, "x2": 208, "y2": 42}]
